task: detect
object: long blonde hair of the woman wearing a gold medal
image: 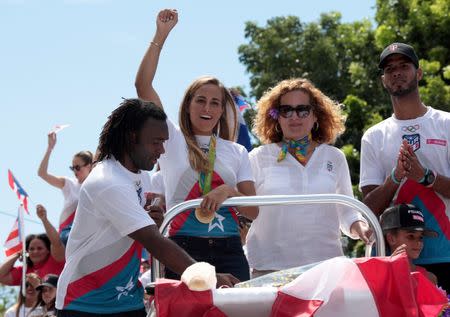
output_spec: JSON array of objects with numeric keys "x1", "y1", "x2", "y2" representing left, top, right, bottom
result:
[{"x1": 179, "y1": 76, "x2": 237, "y2": 172}]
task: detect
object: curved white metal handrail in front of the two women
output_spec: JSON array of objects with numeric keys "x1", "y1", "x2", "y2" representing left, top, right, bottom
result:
[{"x1": 152, "y1": 194, "x2": 385, "y2": 282}]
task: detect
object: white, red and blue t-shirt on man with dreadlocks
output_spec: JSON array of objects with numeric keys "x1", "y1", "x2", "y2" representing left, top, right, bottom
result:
[{"x1": 56, "y1": 159, "x2": 155, "y2": 314}]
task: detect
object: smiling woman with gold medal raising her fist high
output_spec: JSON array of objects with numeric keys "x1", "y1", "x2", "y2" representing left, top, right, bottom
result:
[{"x1": 136, "y1": 10, "x2": 258, "y2": 280}]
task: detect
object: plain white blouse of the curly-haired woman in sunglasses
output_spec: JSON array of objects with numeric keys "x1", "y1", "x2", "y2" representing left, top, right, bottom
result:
[{"x1": 246, "y1": 144, "x2": 363, "y2": 270}]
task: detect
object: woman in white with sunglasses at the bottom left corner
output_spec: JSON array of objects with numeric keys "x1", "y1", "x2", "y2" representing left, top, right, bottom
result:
[{"x1": 4, "y1": 273, "x2": 41, "y2": 317}]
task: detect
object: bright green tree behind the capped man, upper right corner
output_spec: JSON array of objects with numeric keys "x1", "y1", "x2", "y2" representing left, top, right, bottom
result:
[{"x1": 375, "y1": 0, "x2": 450, "y2": 111}]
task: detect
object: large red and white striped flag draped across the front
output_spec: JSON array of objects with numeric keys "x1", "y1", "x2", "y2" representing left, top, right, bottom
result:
[{"x1": 155, "y1": 254, "x2": 447, "y2": 317}]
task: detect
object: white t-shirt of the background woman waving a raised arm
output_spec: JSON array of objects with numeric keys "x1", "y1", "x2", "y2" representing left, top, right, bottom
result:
[{"x1": 59, "y1": 177, "x2": 81, "y2": 231}]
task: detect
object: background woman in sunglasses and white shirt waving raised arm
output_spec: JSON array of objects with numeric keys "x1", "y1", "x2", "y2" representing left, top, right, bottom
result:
[{"x1": 38, "y1": 132, "x2": 93, "y2": 245}]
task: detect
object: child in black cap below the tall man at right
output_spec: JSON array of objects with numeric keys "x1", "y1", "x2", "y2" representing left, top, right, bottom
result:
[{"x1": 380, "y1": 204, "x2": 438, "y2": 284}]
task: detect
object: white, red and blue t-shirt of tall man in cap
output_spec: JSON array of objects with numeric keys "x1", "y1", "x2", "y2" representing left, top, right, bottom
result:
[{"x1": 359, "y1": 107, "x2": 450, "y2": 264}]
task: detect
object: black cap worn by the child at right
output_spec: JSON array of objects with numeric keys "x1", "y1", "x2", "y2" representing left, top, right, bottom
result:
[{"x1": 380, "y1": 204, "x2": 438, "y2": 238}]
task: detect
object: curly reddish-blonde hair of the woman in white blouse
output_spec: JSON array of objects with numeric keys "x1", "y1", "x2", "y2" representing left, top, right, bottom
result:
[{"x1": 253, "y1": 78, "x2": 345, "y2": 144}]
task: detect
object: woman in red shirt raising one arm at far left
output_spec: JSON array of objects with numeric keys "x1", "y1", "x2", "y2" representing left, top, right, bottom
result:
[{"x1": 0, "y1": 205, "x2": 65, "y2": 285}]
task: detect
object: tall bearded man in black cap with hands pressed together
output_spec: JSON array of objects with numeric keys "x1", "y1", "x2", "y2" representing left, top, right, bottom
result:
[{"x1": 359, "y1": 43, "x2": 450, "y2": 291}]
